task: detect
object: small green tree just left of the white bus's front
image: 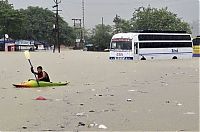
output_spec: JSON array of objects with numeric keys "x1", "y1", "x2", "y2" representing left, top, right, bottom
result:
[{"x1": 89, "y1": 24, "x2": 112, "y2": 50}]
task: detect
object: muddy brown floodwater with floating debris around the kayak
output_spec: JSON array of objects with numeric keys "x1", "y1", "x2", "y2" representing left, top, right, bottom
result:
[{"x1": 0, "y1": 50, "x2": 199, "y2": 131}]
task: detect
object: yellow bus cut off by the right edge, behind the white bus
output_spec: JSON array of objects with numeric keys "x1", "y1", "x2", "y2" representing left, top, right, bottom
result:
[{"x1": 193, "y1": 36, "x2": 200, "y2": 57}]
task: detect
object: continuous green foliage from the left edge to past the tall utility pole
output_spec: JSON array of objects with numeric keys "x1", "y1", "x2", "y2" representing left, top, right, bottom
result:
[{"x1": 0, "y1": 0, "x2": 75, "y2": 45}]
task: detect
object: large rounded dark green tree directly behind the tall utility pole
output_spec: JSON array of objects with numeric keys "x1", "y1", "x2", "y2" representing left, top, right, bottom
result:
[{"x1": 20, "y1": 7, "x2": 75, "y2": 45}]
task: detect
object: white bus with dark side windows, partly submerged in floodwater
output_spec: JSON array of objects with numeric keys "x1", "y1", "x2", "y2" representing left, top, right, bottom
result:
[{"x1": 110, "y1": 31, "x2": 193, "y2": 60}]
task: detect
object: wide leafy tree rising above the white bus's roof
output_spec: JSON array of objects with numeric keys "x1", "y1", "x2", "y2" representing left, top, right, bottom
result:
[{"x1": 131, "y1": 6, "x2": 191, "y2": 33}]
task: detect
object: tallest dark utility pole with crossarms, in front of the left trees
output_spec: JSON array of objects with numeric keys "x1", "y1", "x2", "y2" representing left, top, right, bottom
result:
[{"x1": 53, "y1": 0, "x2": 62, "y2": 53}]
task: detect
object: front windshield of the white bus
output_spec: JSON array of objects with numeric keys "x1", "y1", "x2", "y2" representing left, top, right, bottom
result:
[{"x1": 111, "y1": 41, "x2": 132, "y2": 50}]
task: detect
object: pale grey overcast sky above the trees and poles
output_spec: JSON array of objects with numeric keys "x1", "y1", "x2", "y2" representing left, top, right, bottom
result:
[{"x1": 9, "y1": 0, "x2": 200, "y2": 34}]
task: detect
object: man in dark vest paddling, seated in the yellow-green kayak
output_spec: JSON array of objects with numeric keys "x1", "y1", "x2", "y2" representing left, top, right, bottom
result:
[{"x1": 31, "y1": 66, "x2": 50, "y2": 82}]
